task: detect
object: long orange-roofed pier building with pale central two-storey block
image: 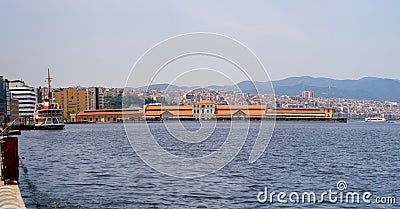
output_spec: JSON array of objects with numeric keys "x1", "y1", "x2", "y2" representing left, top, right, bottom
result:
[{"x1": 143, "y1": 100, "x2": 347, "y2": 122}]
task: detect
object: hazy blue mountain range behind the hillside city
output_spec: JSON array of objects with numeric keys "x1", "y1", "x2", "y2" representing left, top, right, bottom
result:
[{"x1": 134, "y1": 76, "x2": 400, "y2": 102}]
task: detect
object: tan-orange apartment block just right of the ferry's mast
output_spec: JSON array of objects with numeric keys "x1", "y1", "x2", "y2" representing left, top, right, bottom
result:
[{"x1": 53, "y1": 87, "x2": 88, "y2": 119}]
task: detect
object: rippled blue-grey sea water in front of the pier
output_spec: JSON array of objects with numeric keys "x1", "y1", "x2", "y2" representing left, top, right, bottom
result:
[{"x1": 19, "y1": 121, "x2": 400, "y2": 208}]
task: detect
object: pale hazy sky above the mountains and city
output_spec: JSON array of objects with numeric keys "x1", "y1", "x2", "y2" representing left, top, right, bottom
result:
[{"x1": 0, "y1": 0, "x2": 400, "y2": 87}]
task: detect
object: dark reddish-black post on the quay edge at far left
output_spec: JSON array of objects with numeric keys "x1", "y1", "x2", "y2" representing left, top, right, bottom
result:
[{"x1": 1, "y1": 137, "x2": 19, "y2": 184}]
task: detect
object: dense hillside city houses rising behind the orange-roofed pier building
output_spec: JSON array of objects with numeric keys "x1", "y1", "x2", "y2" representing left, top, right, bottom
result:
[{"x1": 124, "y1": 89, "x2": 400, "y2": 120}]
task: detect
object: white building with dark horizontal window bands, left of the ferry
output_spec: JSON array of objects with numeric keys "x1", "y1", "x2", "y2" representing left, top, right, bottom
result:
[{"x1": 10, "y1": 80, "x2": 37, "y2": 117}]
